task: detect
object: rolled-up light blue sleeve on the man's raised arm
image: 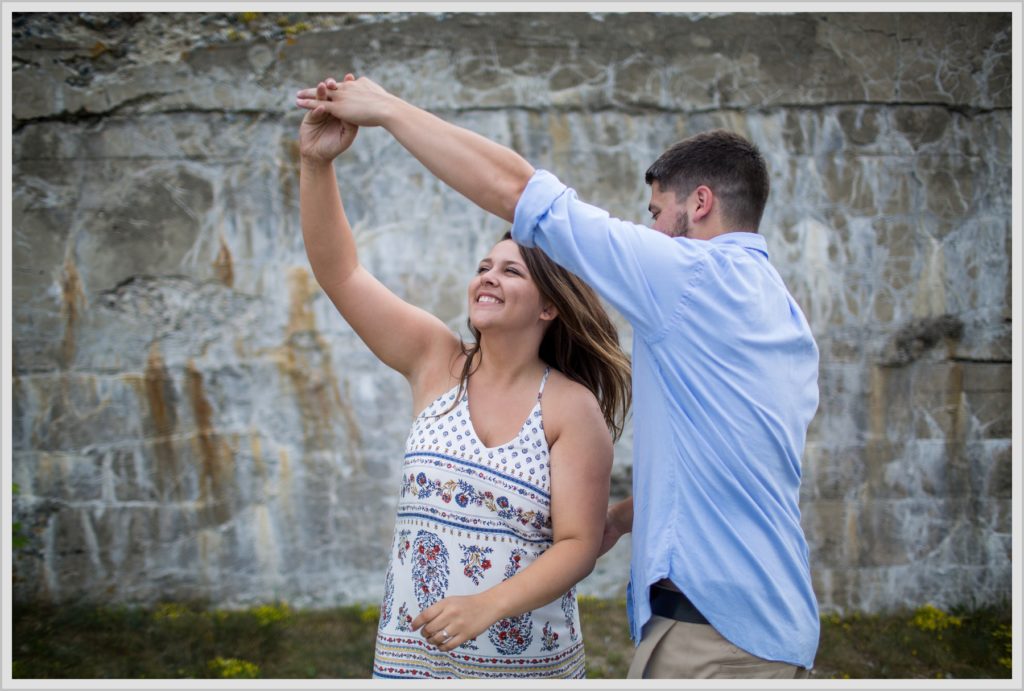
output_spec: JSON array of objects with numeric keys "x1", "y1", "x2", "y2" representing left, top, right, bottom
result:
[{"x1": 512, "y1": 169, "x2": 707, "y2": 339}]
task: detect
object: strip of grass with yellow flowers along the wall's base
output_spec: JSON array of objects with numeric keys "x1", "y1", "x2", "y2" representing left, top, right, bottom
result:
[{"x1": 12, "y1": 597, "x2": 1012, "y2": 679}]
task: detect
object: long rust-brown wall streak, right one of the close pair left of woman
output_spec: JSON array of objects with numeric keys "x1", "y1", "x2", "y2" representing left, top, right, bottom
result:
[{"x1": 185, "y1": 360, "x2": 233, "y2": 524}]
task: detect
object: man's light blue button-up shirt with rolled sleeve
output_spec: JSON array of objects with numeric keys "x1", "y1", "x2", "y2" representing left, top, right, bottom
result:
[{"x1": 512, "y1": 170, "x2": 819, "y2": 668}]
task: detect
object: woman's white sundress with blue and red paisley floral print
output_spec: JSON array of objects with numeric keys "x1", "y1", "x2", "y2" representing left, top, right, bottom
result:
[{"x1": 373, "y1": 369, "x2": 585, "y2": 679}]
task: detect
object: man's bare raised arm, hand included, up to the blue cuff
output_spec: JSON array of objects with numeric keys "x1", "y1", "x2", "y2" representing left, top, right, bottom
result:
[{"x1": 296, "y1": 77, "x2": 534, "y2": 222}]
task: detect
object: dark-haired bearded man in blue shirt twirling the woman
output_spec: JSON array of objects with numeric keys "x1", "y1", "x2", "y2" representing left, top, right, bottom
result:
[{"x1": 297, "y1": 75, "x2": 819, "y2": 679}]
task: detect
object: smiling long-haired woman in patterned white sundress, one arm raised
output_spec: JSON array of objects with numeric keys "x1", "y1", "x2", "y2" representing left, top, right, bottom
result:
[{"x1": 300, "y1": 78, "x2": 630, "y2": 679}]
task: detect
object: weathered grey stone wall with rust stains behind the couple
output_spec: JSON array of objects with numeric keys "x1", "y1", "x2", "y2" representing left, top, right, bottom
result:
[{"x1": 5, "y1": 12, "x2": 1012, "y2": 611}]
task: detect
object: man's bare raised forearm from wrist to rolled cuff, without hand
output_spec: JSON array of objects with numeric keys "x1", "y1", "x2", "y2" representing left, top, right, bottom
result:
[{"x1": 382, "y1": 98, "x2": 534, "y2": 222}]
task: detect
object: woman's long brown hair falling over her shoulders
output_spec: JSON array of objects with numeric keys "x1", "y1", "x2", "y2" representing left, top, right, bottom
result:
[{"x1": 455, "y1": 232, "x2": 633, "y2": 440}]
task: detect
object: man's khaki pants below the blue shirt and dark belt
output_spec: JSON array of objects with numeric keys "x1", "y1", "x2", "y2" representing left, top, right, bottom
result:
[{"x1": 628, "y1": 615, "x2": 808, "y2": 679}]
